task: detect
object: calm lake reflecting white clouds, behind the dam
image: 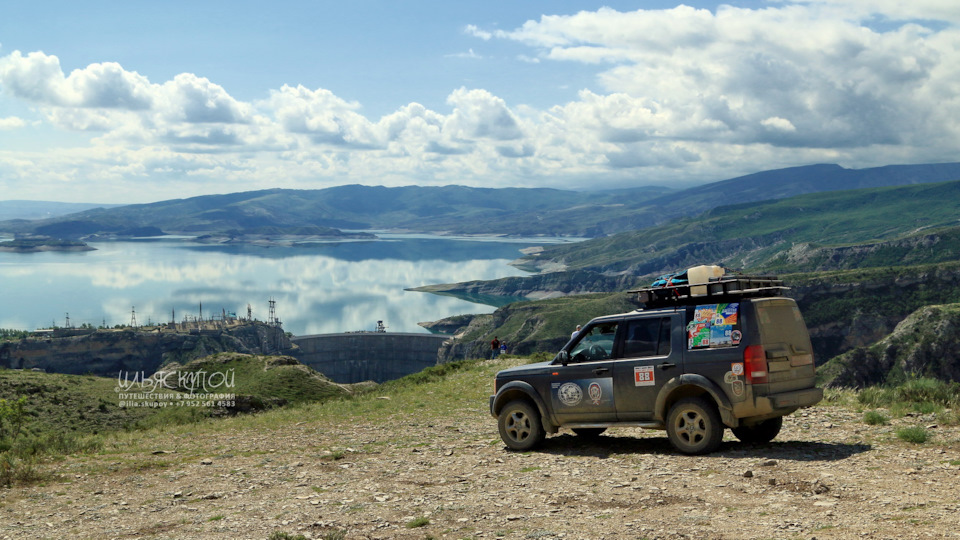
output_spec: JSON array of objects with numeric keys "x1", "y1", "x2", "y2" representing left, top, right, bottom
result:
[{"x1": 0, "y1": 233, "x2": 563, "y2": 335}]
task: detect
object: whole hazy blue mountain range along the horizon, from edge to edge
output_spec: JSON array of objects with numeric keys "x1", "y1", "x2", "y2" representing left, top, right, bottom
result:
[{"x1": 0, "y1": 163, "x2": 960, "y2": 238}]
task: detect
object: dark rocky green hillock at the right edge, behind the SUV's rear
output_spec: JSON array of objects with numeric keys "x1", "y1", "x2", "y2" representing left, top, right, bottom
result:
[{"x1": 820, "y1": 304, "x2": 960, "y2": 388}]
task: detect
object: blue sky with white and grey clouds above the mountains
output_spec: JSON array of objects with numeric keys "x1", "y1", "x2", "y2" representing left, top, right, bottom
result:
[{"x1": 0, "y1": 0, "x2": 960, "y2": 204}]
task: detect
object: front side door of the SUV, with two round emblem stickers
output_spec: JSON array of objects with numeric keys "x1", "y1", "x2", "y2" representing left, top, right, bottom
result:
[{"x1": 550, "y1": 319, "x2": 620, "y2": 425}]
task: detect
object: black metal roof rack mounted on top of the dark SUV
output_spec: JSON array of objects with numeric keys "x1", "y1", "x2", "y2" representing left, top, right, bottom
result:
[{"x1": 627, "y1": 274, "x2": 790, "y2": 308}]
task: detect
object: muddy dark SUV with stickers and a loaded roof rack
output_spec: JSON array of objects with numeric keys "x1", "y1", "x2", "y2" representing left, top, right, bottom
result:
[{"x1": 490, "y1": 276, "x2": 823, "y2": 454}]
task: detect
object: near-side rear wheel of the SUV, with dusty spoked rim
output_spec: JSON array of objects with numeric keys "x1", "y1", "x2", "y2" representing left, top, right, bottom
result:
[{"x1": 667, "y1": 397, "x2": 723, "y2": 454}]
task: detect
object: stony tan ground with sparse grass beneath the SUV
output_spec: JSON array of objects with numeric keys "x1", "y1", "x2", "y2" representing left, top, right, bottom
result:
[{"x1": 0, "y1": 364, "x2": 960, "y2": 540}]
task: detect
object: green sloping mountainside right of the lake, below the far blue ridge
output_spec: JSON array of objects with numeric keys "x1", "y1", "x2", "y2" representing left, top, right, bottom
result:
[{"x1": 519, "y1": 181, "x2": 960, "y2": 276}]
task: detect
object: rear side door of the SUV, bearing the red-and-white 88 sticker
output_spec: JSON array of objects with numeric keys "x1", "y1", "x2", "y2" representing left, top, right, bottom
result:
[{"x1": 613, "y1": 312, "x2": 684, "y2": 421}]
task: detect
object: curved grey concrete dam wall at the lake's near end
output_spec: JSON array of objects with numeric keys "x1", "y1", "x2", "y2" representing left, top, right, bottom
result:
[{"x1": 290, "y1": 332, "x2": 450, "y2": 383}]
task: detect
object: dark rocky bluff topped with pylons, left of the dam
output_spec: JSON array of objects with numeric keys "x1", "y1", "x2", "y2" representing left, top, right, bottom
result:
[{"x1": 0, "y1": 322, "x2": 296, "y2": 377}]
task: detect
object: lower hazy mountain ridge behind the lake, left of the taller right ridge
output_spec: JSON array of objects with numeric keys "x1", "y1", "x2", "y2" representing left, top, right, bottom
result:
[{"x1": 0, "y1": 185, "x2": 670, "y2": 238}]
